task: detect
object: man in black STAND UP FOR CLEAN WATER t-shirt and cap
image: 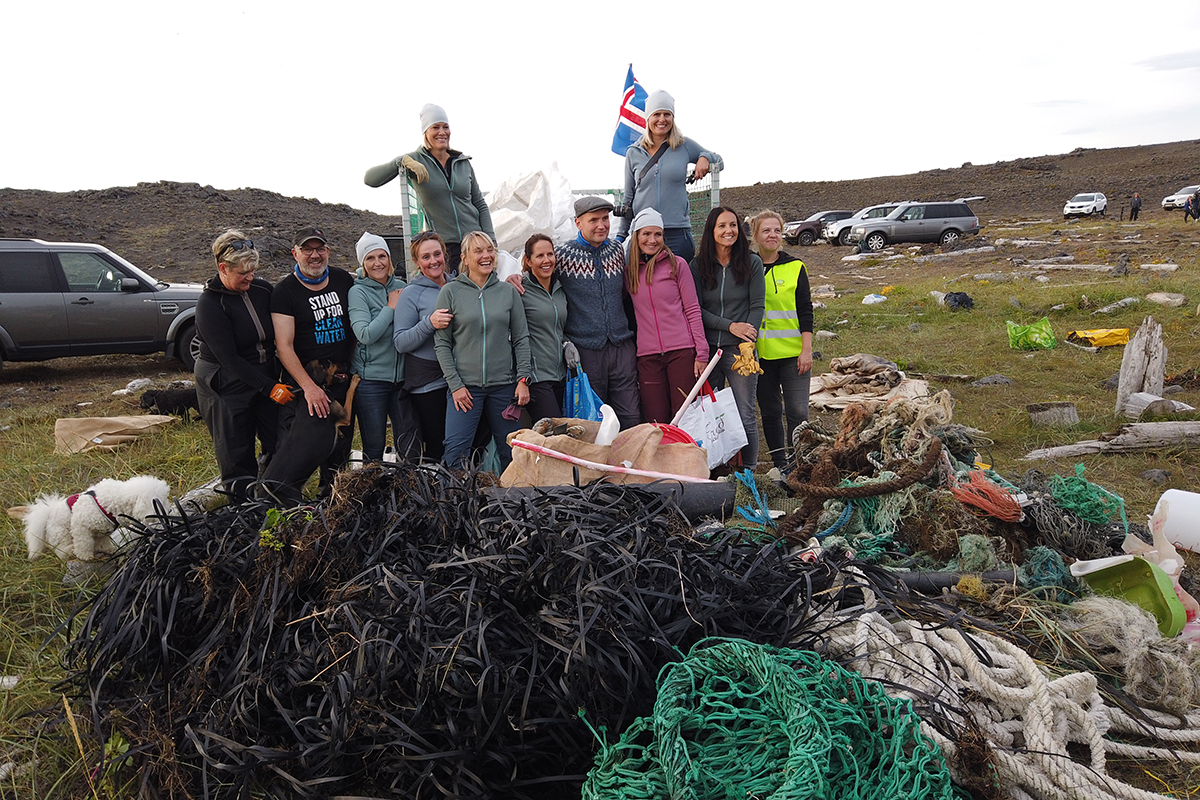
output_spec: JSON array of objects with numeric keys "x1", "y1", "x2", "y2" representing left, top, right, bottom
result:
[{"x1": 262, "y1": 227, "x2": 354, "y2": 505}]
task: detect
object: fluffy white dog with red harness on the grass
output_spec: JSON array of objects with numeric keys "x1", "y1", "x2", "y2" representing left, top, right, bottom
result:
[{"x1": 8, "y1": 475, "x2": 170, "y2": 561}]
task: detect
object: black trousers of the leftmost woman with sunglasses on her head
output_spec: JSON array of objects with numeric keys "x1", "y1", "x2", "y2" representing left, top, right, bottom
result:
[{"x1": 196, "y1": 359, "x2": 280, "y2": 501}]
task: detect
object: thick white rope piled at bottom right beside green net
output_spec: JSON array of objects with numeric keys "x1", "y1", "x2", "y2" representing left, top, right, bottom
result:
[{"x1": 828, "y1": 612, "x2": 1185, "y2": 800}]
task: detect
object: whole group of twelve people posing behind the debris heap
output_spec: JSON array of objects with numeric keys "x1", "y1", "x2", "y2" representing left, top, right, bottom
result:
[{"x1": 196, "y1": 92, "x2": 812, "y2": 505}]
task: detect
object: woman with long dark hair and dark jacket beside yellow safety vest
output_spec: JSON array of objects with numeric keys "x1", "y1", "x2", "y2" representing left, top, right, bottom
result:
[{"x1": 691, "y1": 206, "x2": 767, "y2": 469}]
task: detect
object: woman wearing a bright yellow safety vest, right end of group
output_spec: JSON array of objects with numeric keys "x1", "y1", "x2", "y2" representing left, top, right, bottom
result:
[{"x1": 750, "y1": 211, "x2": 812, "y2": 477}]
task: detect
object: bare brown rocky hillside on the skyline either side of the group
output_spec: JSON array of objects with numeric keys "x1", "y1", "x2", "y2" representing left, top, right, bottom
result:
[{"x1": 0, "y1": 142, "x2": 1200, "y2": 281}]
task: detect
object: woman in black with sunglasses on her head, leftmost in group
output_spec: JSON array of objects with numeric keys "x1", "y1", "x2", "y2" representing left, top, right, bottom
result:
[{"x1": 196, "y1": 229, "x2": 285, "y2": 503}]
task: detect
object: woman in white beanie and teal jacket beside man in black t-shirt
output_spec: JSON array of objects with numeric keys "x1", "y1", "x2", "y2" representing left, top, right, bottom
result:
[{"x1": 349, "y1": 233, "x2": 421, "y2": 461}]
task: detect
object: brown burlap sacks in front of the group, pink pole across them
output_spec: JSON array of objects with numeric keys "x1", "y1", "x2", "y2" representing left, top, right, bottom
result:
[{"x1": 500, "y1": 419, "x2": 708, "y2": 488}]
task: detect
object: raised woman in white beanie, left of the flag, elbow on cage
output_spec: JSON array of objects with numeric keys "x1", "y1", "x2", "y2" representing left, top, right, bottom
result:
[{"x1": 364, "y1": 103, "x2": 496, "y2": 271}]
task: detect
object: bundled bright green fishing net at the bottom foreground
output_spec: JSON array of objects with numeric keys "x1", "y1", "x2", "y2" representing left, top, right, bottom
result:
[{"x1": 582, "y1": 639, "x2": 954, "y2": 800}]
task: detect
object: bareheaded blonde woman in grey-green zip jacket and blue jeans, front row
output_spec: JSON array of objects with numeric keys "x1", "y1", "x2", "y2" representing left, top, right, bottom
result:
[{"x1": 433, "y1": 230, "x2": 533, "y2": 468}]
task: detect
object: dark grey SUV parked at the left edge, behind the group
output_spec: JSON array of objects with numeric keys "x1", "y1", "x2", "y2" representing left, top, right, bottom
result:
[{"x1": 0, "y1": 239, "x2": 204, "y2": 369}]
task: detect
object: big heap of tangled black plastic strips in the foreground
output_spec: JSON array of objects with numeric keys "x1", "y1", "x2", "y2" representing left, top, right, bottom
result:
[{"x1": 62, "y1": 467, "x2": 854, "y2": 799}]
